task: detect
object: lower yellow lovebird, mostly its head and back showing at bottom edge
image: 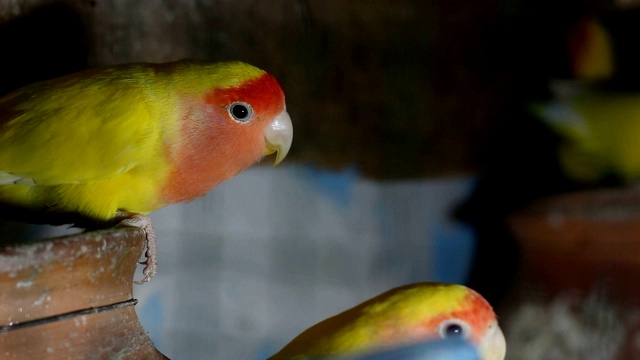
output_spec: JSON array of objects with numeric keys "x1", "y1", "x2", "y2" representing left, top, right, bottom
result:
[{"x1": 268, "y1": 282, "x2": 506, "y2": 360}]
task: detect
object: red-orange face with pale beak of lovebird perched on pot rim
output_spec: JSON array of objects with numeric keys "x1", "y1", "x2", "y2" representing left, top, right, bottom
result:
[{"x1": 164, "y1": 73, "x2": 292, "y2": 203}]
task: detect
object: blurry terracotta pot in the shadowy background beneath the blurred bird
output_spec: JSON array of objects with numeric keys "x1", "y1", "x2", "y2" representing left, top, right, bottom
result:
[{"x1": 509, "y1": 188, "x2": 640, "y2": 305}]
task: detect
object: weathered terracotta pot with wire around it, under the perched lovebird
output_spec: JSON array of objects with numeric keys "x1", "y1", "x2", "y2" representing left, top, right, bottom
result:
[{"x1": 0, "y1": 228, "x2": 167, "y2": 360}]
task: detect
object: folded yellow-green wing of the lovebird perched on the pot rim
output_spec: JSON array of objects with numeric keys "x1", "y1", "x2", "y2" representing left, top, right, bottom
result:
[{"x1": 0, "y1": 65, "x2": 168, "y2": 185}]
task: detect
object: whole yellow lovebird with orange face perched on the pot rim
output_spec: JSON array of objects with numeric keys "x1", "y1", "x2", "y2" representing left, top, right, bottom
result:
[{"x1": 0, "y1": 60, "x2": 293, "y2": 282}]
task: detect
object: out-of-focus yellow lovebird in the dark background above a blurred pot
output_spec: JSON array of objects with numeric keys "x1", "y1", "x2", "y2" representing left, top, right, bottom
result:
[{"x1": 532, "y1": 16, "x2": 640, "y2": 184}]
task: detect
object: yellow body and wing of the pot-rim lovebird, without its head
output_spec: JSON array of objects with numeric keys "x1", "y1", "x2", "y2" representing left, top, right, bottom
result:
[{"x1": 0, "y1": 65, "x2": 176, "y2": 219}]
